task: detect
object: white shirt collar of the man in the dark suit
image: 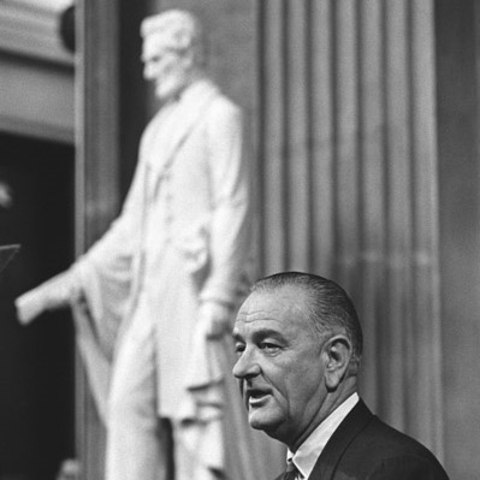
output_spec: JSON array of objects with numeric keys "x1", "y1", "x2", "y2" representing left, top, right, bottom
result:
[{"x1": 287, "y1": 392, "x2": 360, "y2": 480}]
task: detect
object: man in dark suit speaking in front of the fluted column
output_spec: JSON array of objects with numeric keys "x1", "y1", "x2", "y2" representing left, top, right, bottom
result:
[{"x1": 233, "y1": 272, "x2": 448, "y2": 480}]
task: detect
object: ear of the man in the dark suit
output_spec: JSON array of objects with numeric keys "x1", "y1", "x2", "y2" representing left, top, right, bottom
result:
[{"x1": 324, "y1": 334, "x2": 352, "y2": 391}]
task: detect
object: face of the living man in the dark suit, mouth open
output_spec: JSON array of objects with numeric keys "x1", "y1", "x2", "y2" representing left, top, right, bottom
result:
[{"x1": 233, "y1": 286, "x2": 326, "y2": 445}]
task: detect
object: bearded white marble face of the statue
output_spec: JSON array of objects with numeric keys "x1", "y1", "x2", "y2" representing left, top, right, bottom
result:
[{"x1": 142, "y1": 33, "x2": 191, "y2": 100}]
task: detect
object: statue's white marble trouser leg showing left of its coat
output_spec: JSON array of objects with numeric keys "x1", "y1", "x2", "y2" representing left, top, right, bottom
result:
[{"x1": 106, "y1": 306, "x2": 171, "y2": 480}]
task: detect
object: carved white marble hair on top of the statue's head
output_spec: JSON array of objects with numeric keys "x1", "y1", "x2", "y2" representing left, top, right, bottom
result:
[{"x1": 140, "y1": 9, "x2": 204, "y2": 65}]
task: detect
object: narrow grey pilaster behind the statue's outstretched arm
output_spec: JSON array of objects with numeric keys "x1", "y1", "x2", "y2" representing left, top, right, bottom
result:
[{"x1": 75, "y1": 0, "x2": 120, "y2": 480}]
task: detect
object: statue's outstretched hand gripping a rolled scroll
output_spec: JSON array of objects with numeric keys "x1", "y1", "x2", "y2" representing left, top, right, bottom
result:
[{"x1": 15, "y1": 271, "x2": 73, "y2": 325}]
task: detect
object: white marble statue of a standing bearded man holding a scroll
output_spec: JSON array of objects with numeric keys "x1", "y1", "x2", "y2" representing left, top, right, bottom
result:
[{"x1": 17, "y1": 10, "x2": 250, "y2": 480}]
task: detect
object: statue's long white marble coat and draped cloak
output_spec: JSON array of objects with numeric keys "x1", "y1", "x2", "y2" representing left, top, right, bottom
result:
[{"x1": 69, "y1": 80, "x2": 284, "y2": 479}]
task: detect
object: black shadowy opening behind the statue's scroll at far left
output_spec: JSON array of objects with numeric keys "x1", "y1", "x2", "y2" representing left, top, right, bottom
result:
[{"x1": 0, "y1": 134, "x2": 74, "y2": 480}]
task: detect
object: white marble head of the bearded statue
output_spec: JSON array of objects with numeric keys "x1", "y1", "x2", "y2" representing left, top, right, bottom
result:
[{"x1": 141, "y1": 10, "x2": 204, "y2": 100}]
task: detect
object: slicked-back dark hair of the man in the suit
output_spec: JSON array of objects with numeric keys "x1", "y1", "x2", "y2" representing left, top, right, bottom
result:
[{"x1": 251, "y1": 272, "x2": 363, "y2": 366}]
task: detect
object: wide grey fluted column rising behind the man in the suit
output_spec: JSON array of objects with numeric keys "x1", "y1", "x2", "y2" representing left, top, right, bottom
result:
[{"x1": 258, "y1": 0, "x2": 442, "y2": 455}]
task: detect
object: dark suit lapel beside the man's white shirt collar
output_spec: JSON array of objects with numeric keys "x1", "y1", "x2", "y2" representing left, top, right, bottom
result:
[{"x1": 309, "y1": 400, "x2": 375, "y2": 480}]
